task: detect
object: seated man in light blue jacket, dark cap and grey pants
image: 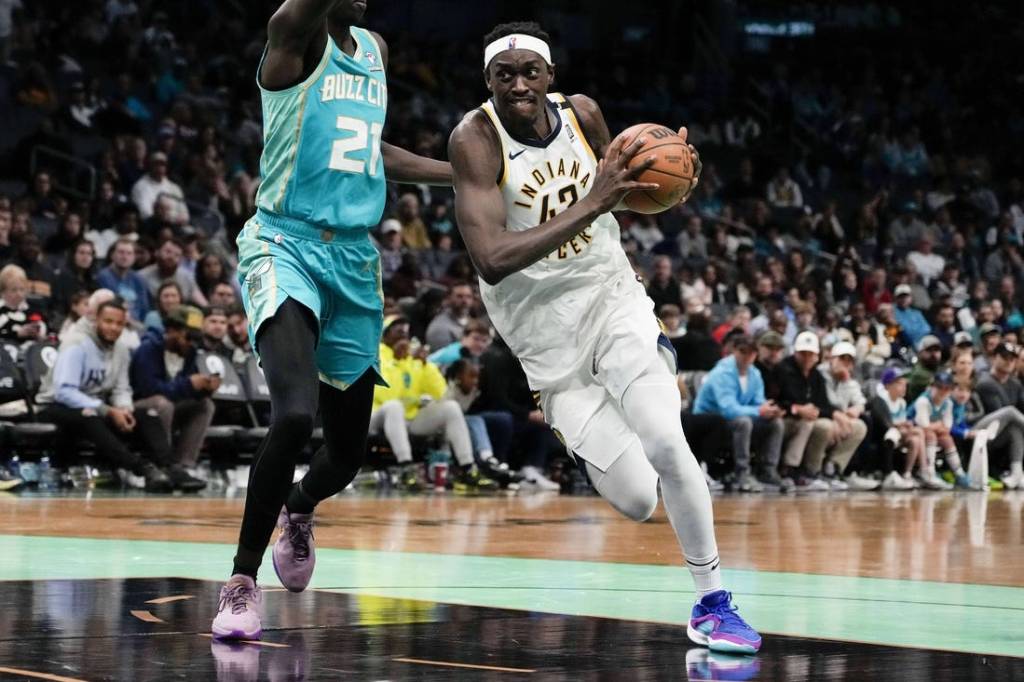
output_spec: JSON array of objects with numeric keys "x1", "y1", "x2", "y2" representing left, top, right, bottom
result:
[{"x1": 693, "y1": 336, "x2": 784, "y2": 493}]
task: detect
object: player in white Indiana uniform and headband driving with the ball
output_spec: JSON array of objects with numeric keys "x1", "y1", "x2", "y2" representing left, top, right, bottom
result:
[{"x1": 449, "y1": 23, "x2": 761, "y2": 653}]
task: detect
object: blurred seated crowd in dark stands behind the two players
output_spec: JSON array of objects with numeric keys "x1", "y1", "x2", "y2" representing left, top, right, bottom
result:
[{"x1": 0, "y1": 0, "x2": 1024, "y2": 492}]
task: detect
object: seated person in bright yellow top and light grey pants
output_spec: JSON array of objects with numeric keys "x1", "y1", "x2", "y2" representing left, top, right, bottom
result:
[{"x1": 370, "y1": 316, "x2": 498, "y2": 492}]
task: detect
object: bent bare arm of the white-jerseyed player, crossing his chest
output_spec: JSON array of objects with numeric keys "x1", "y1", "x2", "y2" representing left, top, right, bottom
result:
[{"x1": 449, "y1": 112, "x2": 657, "y2": 285}]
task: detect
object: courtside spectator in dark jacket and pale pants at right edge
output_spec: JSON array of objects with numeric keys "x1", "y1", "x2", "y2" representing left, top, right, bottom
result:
[{"x1": 974, "y1": 343, "x2": 1024, "y2": 489}]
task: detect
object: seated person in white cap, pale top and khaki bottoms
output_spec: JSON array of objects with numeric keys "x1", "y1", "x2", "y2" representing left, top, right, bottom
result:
[{"x1": 819, "y1": 341, "x2": 879, "y2": 491}]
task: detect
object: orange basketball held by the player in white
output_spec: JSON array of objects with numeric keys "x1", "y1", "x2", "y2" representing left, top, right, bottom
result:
[{"x1": 618, "y1": 123, "x2": 694, "y2": 213}]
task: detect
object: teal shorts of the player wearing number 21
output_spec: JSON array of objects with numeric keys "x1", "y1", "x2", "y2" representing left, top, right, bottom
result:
[{"x1": 238, "y1": 211, "x2": 384, "y2": 390}]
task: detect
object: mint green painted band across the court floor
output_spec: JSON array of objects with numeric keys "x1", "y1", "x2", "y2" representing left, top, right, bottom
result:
[{"x1": 0, "y1": 536, "x2": 1024, "y2": 656}]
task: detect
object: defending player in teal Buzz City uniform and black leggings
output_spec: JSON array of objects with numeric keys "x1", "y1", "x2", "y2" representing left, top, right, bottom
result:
[{"x1": 213, "y1": 0, "x2": 452, "y2": 639}]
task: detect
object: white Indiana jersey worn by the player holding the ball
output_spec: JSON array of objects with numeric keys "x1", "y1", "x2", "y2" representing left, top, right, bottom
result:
[{"x1": 480, "y1": 93, "x2": 657, "y2": 391}]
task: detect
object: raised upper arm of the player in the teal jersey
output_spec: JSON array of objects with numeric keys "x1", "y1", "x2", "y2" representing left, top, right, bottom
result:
[{"x1": 259, "y1": 0, "x2": 335, "y2": 90}]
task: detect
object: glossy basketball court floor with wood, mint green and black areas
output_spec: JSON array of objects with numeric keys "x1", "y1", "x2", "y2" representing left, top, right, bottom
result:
[{"x1": 0, "y1": 485, "x2": 1024, "y2": 681}]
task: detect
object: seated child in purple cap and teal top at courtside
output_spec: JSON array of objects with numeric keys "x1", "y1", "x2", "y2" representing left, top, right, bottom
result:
[{"x1": 870, "y1": 367, "x2": 925, "y2": 491}]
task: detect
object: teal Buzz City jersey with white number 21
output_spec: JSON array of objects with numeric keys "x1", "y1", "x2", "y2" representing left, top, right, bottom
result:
[{"x1": 256, "y1": 27, "x2": 387, "y2": 231}]
